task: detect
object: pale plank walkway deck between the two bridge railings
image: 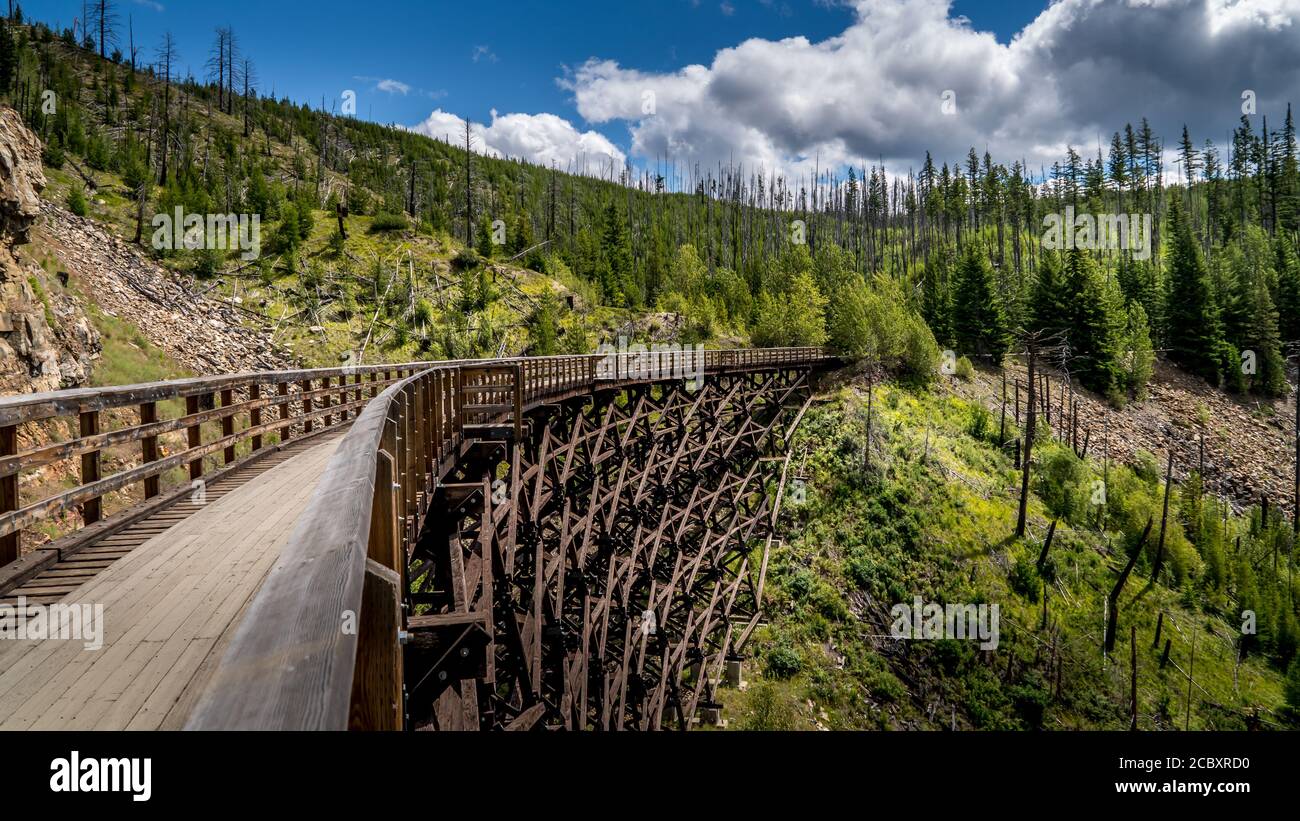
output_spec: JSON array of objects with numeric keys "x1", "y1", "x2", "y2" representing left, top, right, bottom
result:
[{"x1": 0, "y1": 433, "x2": 339, "y2": 730}]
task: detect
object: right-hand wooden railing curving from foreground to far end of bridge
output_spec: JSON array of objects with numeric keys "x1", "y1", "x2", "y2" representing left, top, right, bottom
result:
[{"x1": 180, "y1": 348, "x2": 833, "y2": 730}]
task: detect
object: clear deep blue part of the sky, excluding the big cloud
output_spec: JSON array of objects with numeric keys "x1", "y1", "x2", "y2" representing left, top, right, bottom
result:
[{"x1": 22, "y1": 0, "x2": 1043, "y2": 148}]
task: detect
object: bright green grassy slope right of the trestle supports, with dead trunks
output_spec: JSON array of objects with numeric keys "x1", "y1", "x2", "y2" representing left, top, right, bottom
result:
[{"x1": 723, "y1": 374, "x2": 1300, "y2": 730}]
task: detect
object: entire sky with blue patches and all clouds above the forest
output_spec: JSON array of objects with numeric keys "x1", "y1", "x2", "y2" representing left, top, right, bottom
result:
[{"x1": 23, "y1": 0, "x2": 1300, "y2": 174}]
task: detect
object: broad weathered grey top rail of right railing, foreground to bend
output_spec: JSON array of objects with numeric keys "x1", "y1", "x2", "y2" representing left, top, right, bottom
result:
[{"x1": 187, "y1": 369, "x2": 445, "y2": 730}]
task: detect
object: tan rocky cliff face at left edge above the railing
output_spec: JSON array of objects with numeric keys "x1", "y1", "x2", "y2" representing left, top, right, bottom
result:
[{"x1": 0, "y1": 108, "x2": 100, "y2": 394}]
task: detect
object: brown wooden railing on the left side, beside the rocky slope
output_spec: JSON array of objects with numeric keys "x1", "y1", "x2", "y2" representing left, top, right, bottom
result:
[{"x1": 0, "y1": 364, "x2": 428, "y2": 584}]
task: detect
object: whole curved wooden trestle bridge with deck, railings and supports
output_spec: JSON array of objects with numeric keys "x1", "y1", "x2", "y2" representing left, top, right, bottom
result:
[{"x1": 0, "y1": 348, "x2": 835, "y2": 730}]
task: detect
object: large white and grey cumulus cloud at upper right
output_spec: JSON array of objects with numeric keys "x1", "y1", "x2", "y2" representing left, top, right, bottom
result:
[{"x1": 562, "y1": 0, "x2": 1300, "y2": 174}]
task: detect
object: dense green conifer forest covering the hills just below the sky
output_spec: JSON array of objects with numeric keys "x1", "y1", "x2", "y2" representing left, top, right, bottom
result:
[{"x1": 0, "y1": 0, "x2": 1300, "y2": 392}]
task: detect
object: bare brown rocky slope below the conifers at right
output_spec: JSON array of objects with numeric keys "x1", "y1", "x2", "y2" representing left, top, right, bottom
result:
[{"x1": 954, "y1": 361, "x2": 1295, "y2": 512}]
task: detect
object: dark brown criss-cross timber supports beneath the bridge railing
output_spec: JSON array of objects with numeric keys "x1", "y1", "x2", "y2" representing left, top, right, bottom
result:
[{"x1": 406, "y1": 355, "x2": 811, "y2": 730}]
